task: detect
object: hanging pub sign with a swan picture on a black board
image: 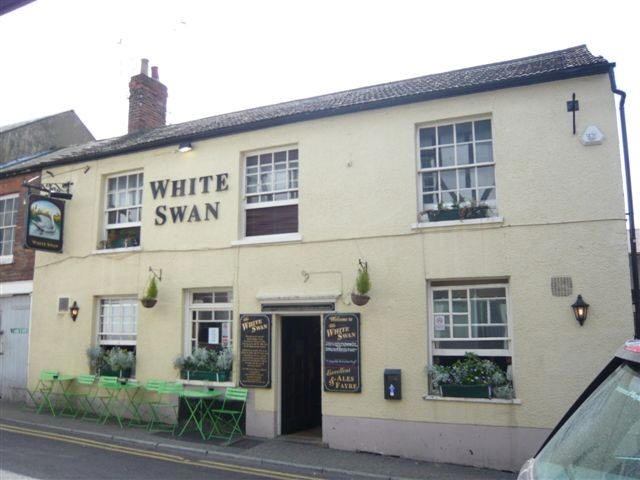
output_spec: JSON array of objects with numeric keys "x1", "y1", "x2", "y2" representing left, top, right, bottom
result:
[{"x1": 24, "y1": 194, "x2": 64, "y2": 252}]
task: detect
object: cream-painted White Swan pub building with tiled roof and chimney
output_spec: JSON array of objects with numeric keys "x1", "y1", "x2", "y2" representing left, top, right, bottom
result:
[{"x1": 20, "y1": 46, "x2": 631, "y2": 470}]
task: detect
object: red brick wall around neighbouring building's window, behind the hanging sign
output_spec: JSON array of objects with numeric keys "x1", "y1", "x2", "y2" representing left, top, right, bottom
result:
[{"x1": 0, "y1": 172, "x2": 40, "y2": 283}]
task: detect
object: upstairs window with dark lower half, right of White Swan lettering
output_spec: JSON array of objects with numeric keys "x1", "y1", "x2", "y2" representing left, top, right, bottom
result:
[{"x1": 244, "y1": 149, "x2": 298, "y2": 237}]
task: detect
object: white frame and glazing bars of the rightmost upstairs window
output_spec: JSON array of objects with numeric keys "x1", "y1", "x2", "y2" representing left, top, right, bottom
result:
[{"x1": 416, "y1": 116, "x2": 498, "y2": 217}]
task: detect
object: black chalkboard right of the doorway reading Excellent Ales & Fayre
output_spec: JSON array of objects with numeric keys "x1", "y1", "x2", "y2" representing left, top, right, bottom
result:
[{"x1": 323, "y1": 313, "x2": 362, "y2": 393}]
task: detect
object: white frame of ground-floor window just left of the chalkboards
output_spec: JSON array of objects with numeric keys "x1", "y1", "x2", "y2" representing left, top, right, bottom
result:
[{"x1": 183, "y1": 287, "x2": 236, "y2": 356}]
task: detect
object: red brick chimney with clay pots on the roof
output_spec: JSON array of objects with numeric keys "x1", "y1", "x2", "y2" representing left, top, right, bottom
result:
[{"x1": 129, "y1": 58, "x2": 167, "y2": 133}]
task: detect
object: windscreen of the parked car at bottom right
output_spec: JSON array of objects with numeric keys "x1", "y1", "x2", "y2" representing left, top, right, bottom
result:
[{"x1": 534, "y1": 363, "x2": 640, "y2": 480}]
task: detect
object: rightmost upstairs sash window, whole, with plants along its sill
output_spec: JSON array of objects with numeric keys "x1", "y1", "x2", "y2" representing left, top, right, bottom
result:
[{"x1": 418, "y1": 119, "x2": 496, "y2": 222}]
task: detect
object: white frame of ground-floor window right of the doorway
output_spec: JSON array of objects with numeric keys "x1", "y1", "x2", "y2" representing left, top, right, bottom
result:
[{"x1": 427, "y1": 283, "x2": 513, "y2": 358}]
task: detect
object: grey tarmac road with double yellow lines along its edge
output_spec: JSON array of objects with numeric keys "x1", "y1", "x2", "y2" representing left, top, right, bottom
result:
[{"x1": 0, "y1": 421, "x2": 338, "y2": 480}]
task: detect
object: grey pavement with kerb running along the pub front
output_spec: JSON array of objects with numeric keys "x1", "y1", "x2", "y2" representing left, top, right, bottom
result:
[{"x1": 0, "y1": 401, "x2": 517, "y2": 480}]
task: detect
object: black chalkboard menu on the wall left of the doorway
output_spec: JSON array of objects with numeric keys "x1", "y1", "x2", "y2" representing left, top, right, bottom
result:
[{"x1": 240, "y1": 313, "x2": 271, "y2": 388}]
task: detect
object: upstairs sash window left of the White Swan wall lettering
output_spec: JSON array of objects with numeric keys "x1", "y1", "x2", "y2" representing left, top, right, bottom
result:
[{"x1": 103, "y1": 173, "x2": 143, "y2": 248}]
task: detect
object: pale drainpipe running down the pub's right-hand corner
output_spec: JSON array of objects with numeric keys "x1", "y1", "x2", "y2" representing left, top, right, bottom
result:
[{"x1": 609, "y1": 63, "x2": 640, "y2": 339}]
